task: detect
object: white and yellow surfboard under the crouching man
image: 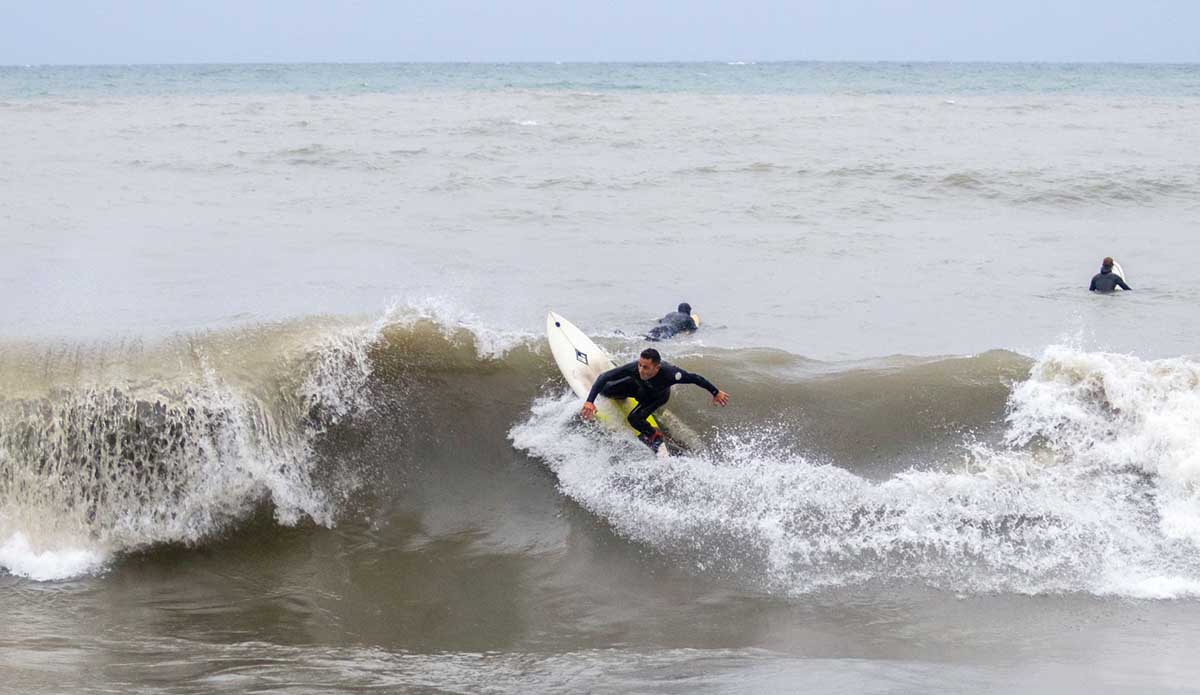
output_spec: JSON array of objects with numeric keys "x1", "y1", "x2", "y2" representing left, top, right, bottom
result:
[{"x1": 546, "y1": 312, "x2": 670, "y2": 457}]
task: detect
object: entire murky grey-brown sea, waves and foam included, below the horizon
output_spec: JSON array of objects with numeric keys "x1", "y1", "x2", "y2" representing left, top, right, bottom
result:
[{"x1": 0, "y1": 64, "x2": 1200, "y2": 693}]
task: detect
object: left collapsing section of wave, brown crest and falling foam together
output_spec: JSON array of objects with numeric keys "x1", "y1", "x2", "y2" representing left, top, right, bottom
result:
[{"x1": 0, "y1": 314, "x2": 383, "y2": 581}]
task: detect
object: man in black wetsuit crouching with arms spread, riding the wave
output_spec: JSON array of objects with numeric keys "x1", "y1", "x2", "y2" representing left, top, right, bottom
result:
[{"x1": 580, "y1": 348, "x2": 730, "y2": 451}]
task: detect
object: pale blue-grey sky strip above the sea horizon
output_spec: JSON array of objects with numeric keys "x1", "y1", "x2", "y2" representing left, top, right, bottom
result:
[{"x1": 0, "y1": 0, "x2": 1200, "y2": 65}]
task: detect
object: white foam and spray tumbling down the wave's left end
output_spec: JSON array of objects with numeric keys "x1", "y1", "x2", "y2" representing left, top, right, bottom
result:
[{"x1": 0, "y1": 319, "x2": 385, "y2": 580}]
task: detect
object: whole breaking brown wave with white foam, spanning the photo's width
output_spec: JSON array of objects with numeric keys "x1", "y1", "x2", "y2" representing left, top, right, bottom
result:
[{"x1": 0, "y1": 302, "x2": 1200, "y2": 598}]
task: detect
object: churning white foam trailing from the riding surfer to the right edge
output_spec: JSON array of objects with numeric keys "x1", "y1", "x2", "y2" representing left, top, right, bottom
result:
[{"x1": 510, "y1": 347, "x2": 1200, "y2": 599}]
